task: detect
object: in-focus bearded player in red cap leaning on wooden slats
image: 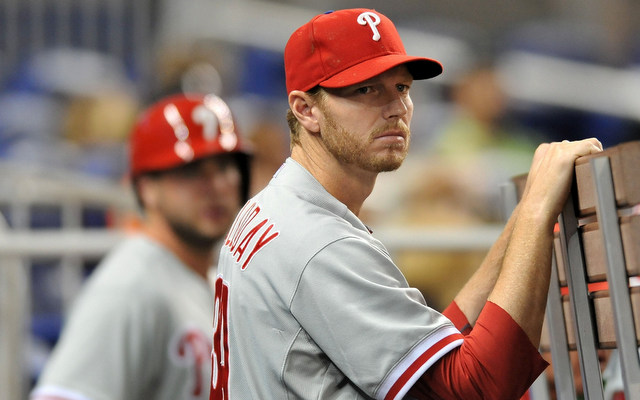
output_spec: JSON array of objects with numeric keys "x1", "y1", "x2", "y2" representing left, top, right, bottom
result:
[{"x1": 211, "y1": 9, "x2": 602, "y2": 400}]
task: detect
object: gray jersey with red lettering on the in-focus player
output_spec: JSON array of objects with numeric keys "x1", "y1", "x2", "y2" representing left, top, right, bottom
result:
[{"x1": 211, "y1": 159, "x2": 462, "y2": 400}]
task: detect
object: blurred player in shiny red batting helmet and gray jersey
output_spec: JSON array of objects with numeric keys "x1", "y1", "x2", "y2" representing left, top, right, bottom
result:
[{"x1": 31, "y1": 95, "x2": 249, "y2": 400}]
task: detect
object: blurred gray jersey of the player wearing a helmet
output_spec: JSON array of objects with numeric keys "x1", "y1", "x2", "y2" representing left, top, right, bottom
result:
[{"x1": 35, "y1": 236, "x2": 213, "y2": 400}]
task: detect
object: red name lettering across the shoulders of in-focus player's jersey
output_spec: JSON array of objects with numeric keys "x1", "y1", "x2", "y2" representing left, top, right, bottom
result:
[{"x1": 224, "y1": 203, "x2": 280, "y2": 269}]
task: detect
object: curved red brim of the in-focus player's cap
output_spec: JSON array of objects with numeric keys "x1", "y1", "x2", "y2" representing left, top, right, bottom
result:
[{"x1": 319, "y1": 54, "x2": 442, "y2": 88}]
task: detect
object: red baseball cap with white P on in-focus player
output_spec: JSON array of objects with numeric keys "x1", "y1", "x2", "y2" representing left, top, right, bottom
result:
[{"x1": 284, "y1": 8, "x2": 442, "y2": 93}]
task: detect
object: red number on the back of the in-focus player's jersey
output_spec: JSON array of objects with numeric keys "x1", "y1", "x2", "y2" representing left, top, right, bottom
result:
[{"x1": 209, "y1": 276, "x2": 229, "y2": 400}]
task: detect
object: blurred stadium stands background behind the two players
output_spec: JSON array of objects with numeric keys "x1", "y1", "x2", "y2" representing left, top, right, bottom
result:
[{"x1": 0, "y1": 0, "x2": 640, "y2": 400}]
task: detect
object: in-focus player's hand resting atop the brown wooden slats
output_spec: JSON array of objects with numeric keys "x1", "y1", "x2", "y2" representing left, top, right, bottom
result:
[{"x1": 522, "y1": 138, "x2": 602, "y2": 223}]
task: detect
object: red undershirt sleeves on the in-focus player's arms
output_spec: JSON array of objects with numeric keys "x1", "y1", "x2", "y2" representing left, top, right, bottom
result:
[{"x1": 408, "y1": 302, "x2": 548, "y2": 400}]
